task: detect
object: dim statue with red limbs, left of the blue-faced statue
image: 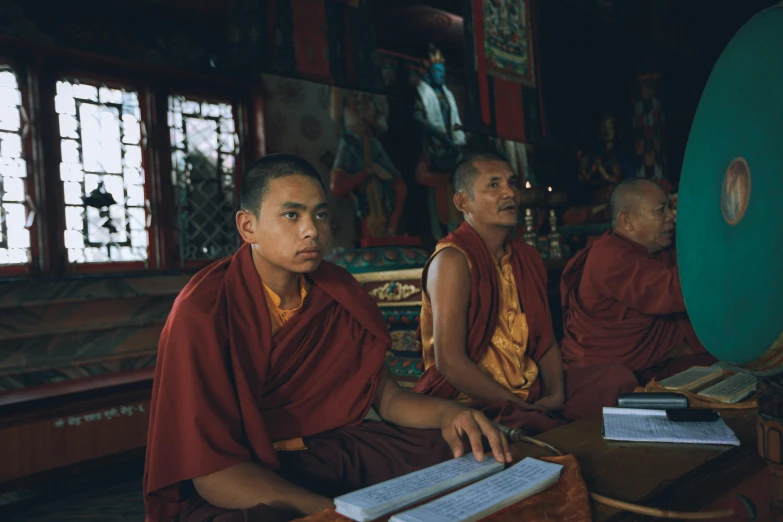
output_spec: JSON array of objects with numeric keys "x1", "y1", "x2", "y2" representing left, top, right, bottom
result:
[{"x1": 329, "y1": 87, "x2": 407, "y2": 248}]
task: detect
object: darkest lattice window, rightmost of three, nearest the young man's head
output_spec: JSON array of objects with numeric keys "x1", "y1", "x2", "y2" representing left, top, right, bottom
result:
[{"x1": 168, "y1": 96, "x2": 239, "y2": 263}]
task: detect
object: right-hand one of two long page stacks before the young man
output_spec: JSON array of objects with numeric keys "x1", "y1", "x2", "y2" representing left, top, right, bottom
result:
[{"x1": 390, "y1": 457, "x2": 563, "y2": 522}]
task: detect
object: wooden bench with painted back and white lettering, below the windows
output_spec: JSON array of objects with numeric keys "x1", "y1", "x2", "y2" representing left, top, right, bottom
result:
[{"x1": 0, "y1": 275, "x2": 185, "y2": 490}]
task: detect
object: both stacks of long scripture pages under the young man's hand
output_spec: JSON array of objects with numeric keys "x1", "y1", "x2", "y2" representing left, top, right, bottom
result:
[{"x1": 334, "y1": 454, "x2": 563, "y2": 522}]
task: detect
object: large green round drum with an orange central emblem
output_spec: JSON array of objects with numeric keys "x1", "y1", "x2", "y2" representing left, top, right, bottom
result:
[{"x1": 677, "y1": 3, "x2": 783, "y2": 375}]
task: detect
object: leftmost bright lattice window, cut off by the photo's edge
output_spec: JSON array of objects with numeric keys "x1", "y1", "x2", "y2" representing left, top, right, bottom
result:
[{"x1": 0, "y1": 65, "x2": 33, "y2": 266}]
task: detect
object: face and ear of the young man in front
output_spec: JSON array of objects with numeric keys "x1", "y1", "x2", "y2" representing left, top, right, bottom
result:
[{"x1": 237, "y1": 175, "x2": 330, "y2": 274}]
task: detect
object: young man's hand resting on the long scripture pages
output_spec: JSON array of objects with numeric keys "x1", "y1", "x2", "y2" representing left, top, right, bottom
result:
[{"x1": 440, "y1": 403, "x2": 511, "y2": 463}]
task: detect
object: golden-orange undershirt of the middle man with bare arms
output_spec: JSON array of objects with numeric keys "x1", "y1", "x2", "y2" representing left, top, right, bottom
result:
[{"x1": 420, "y1": 243, "x2": 538, "y2": 402}]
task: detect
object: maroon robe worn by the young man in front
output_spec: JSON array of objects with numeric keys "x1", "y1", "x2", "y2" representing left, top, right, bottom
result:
[{"x1": 144, "y1": 245, "x2": 451, "y2": 522}]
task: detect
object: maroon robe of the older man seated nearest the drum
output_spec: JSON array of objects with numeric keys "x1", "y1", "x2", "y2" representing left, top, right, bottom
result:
[{"x1": 561, "y1": 232, "x2": 714, "y2": 378}]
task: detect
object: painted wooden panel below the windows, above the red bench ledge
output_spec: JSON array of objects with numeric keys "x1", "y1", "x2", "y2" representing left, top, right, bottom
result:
[{"x1": 0, "y1": 275, "x2": 190, "y2": 390}]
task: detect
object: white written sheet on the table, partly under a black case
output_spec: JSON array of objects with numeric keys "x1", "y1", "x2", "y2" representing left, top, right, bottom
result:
[{"x1": 604, "y1": 408, "x2": 740, "y2": 446}]
